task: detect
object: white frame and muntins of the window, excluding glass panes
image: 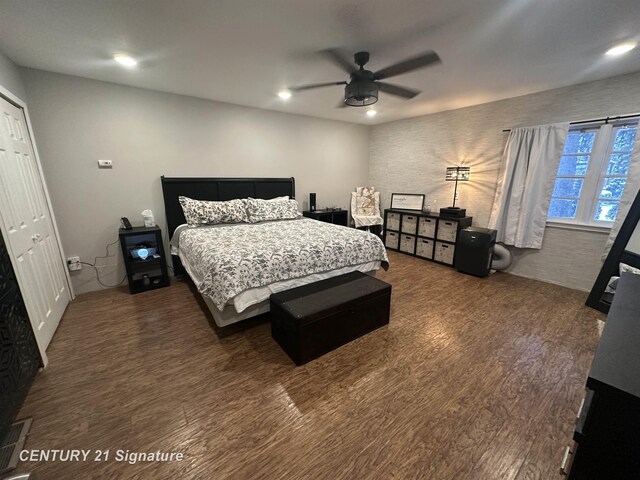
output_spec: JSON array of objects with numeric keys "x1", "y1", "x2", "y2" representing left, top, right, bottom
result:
[{"x1": 547, "y1": 118, "x2": 640, "y2": 229}]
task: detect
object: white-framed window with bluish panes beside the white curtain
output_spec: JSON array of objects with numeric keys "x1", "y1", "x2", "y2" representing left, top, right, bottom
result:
[{"x1": 547, "y1": 123, "x2": 638, "y2": 226}]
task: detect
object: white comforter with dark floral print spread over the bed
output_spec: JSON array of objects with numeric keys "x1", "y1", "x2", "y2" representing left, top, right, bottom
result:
[{"x1": 178, "y1": 218, "x2": 389, "y2": 310}]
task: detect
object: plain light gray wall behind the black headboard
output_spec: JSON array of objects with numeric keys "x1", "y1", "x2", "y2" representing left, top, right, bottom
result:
[{"x1": 21, "y1": 69, "x2": 369, "y2": 293}]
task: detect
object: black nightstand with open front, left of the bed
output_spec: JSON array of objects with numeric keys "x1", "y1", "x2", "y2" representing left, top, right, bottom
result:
[{"x1": 120, "y1": 227, "x2": 169, "y2": 293}]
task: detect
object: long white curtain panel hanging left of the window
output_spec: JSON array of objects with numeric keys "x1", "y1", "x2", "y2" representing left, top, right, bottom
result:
[{"x1": 489, "y1": 123, "x2": 569, "y2": 249}]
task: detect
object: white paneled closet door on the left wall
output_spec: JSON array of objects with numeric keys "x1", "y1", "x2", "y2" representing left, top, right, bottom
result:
[{"x1": 0, "y1": 98, "x2": 70, "y2": 353}]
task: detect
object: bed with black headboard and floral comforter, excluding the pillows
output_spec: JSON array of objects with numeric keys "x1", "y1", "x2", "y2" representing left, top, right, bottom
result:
[{"x1": 161, "y1": 176, "x2": 388, "y2": 327}]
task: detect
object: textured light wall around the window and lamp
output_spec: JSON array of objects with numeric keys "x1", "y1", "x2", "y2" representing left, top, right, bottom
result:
[{"x1": 369, "y1": 73, "x2": 640, "y2": 290}]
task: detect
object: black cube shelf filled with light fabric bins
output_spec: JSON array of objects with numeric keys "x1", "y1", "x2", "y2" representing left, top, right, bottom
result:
[{"x1": 384, "y1": 208, "x2": 473, "y2": 266}]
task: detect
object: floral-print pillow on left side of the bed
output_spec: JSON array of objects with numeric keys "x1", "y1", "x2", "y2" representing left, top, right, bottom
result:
[{"x1": 178, "y1": 196, "x2": 249, "y2": 227}]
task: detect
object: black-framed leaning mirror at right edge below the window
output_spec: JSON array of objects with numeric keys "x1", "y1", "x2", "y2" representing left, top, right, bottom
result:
[{"x1": 586, "y1": 192, "x2": 640, "y2": 313}]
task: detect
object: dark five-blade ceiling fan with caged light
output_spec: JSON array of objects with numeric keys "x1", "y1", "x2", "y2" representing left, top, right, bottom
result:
[{"x1": 289, "y1": 49, "x2": 440, "y2": 107}]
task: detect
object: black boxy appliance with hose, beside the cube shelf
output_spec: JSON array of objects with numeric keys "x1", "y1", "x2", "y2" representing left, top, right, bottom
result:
[{"x1": 454, "y1": 227, "x2": 496, "y2": 277}]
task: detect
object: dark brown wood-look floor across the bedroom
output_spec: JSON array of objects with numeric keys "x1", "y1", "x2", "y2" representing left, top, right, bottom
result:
[{"x1": 18, "y1": 253, "x2": 602, "y2": 480}]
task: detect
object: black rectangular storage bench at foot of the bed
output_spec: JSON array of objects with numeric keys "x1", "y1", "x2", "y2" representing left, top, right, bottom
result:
[{"x1": 271, "y1": 272, "x2": 391, "y2": 365}]
